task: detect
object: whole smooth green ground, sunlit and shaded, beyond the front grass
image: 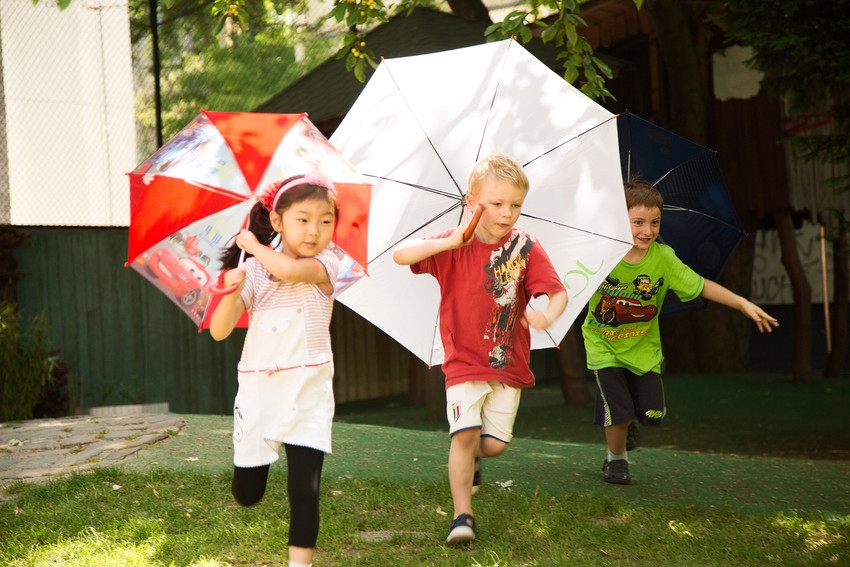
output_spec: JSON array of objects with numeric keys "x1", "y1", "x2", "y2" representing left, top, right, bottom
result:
[{"x1": 121, "y1": 375, "x2": 850, "y2": 515}]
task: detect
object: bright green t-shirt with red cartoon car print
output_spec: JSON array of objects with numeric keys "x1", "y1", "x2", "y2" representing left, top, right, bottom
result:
[{"x1": 581, "y1": 242, "x2": 704, "y2": 375}]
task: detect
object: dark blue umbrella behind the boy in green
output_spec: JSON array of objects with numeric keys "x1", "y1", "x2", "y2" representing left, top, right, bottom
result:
[{"x1": 617, "y1": 111, "x2": 747, "y2": 316}]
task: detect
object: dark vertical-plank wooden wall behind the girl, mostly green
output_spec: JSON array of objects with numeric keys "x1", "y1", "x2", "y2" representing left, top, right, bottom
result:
[{"x1": 15, "y1": 227, "x2": 408, "y2": 414}]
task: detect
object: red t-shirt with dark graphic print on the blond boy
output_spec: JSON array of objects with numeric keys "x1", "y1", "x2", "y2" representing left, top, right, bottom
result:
[{"x1": 410, "y1": 228, "x2": 565, "y2": 388}]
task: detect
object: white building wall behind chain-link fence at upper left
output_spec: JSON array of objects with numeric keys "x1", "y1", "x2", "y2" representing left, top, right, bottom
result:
[{"x1": 0, "y1": 0, "x2": 137, "y2": 226}]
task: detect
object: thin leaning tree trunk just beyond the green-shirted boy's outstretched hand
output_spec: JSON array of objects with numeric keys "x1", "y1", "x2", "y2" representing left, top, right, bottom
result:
[{"x1": 773, "y1": 210, "x2": 812, "y2": 384}]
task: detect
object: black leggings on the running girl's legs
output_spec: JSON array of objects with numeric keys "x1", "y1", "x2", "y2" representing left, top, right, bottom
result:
[{"x1": 231, "y1": 445, "x2": 325, "y2": 548}]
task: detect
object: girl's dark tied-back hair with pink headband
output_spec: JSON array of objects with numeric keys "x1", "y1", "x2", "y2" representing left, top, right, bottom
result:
[{"x1": 221, "y1": 175, "x2": 339, "y2": 270}]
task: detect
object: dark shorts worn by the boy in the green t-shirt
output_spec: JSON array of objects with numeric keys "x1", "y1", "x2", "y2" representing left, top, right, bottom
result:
[{"x1": 593, "y1": 368, "x2": 667, "y2": 427}]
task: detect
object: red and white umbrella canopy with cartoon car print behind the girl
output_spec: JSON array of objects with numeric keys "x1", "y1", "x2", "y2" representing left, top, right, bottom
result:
[{"x1": 127, "y1": 111, "x2": 371, "y2": 328}]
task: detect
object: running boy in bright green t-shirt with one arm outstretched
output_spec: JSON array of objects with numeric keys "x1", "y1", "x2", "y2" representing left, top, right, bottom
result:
[{"x1": 582, "y1": 181, "x2": 779, "y2": 484}]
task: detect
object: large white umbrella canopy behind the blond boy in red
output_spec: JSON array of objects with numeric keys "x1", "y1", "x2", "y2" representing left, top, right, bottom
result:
[{"x1": 331, "y1": 40, "x2": 632, "y2": 365}]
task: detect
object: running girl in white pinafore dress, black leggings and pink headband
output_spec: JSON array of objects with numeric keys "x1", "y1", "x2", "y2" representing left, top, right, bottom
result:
[{"x1": 210, "y1": 176, "x2": 339, "y2": 567}]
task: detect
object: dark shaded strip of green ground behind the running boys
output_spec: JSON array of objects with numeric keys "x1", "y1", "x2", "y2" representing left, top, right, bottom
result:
[{"x1": 336, "y1": 374, "x2": 850, "y2": 460}]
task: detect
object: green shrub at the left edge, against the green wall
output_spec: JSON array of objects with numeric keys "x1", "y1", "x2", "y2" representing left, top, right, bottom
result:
[{"x1": 0, "y1": 303, "x2": 57, "y2": 422}]
